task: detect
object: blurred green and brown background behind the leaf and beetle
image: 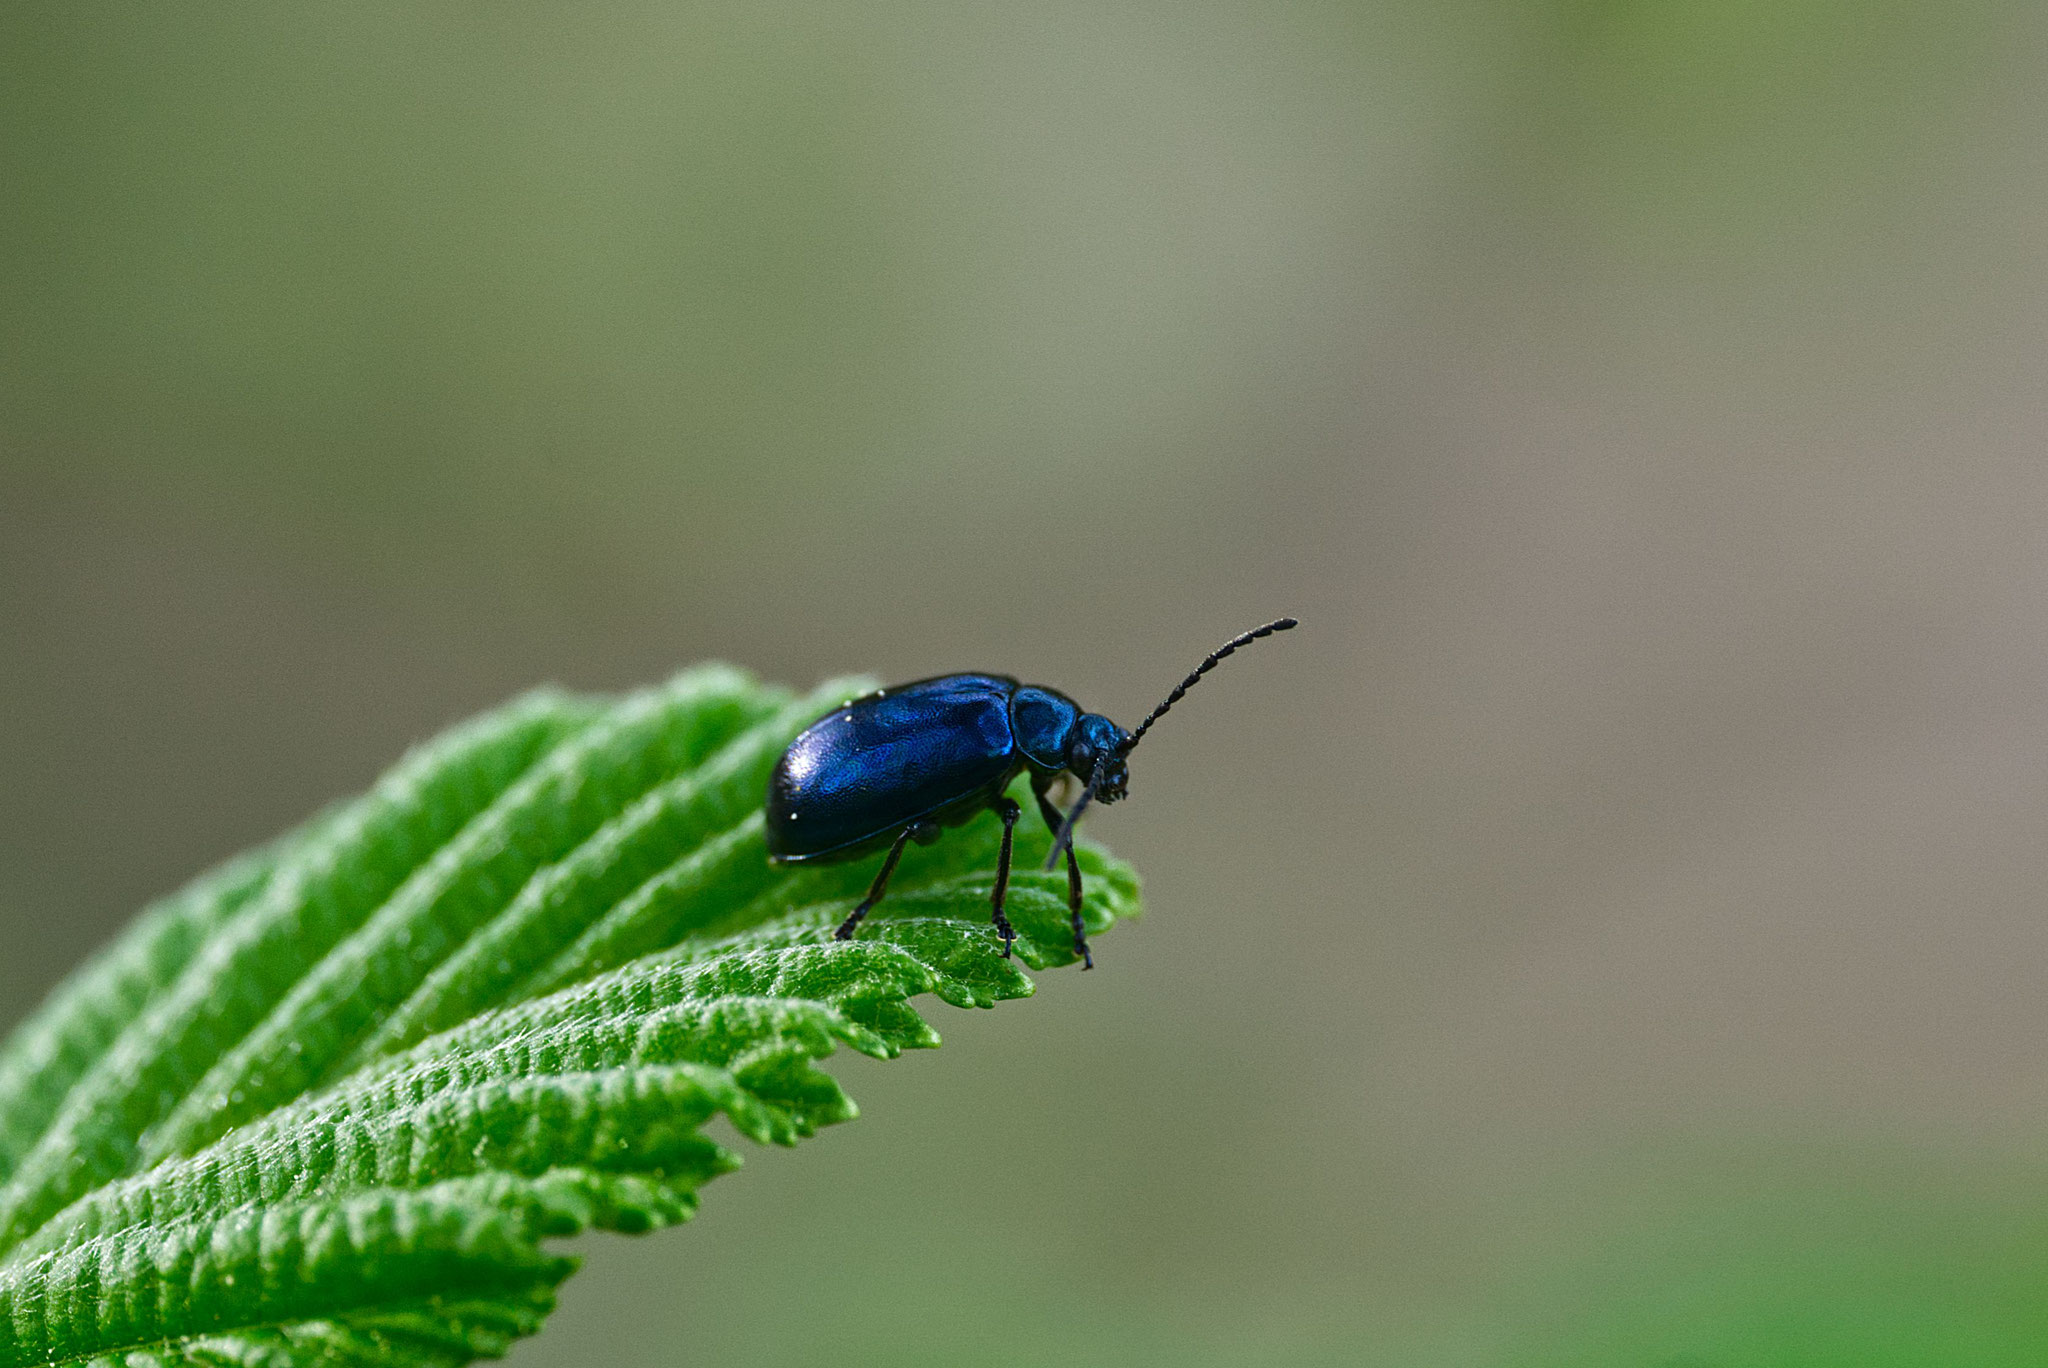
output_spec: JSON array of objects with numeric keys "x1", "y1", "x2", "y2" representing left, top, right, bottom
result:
[{"x1": 0, "y1": 0, "x2": 2048, "y2": 1368}]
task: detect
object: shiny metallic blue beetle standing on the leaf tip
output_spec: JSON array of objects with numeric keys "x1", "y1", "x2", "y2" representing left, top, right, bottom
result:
[{"x1": 766, "y1": 618, "x2": 1294, "y2": 969}]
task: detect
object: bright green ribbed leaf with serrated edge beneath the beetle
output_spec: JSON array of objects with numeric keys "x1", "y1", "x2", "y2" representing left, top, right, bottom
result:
[{"x1": 0, "y1": 666, "x2": 1139, "y2": 1368}]
